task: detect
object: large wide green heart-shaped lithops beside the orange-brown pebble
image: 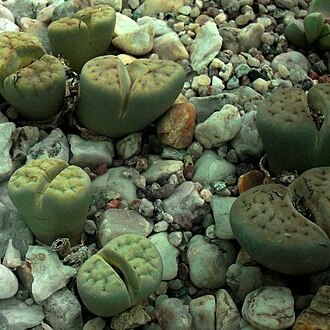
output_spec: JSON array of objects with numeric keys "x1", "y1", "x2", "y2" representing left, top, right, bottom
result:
[{"x1": 76, "y1": 55, "x2": 185, "y2": 138}]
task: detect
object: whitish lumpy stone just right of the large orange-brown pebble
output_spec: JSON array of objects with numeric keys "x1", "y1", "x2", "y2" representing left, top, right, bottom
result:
[{"x1": 194, "y1": 104, "x2": 242, "y2": 149}]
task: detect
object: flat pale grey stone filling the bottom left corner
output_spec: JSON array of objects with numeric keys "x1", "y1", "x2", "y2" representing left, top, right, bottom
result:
[{"x1": 0, "y1": 297, "x2": 45, "y2": 330}]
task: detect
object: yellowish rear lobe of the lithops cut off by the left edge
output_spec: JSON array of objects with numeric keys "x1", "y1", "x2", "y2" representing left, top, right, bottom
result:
[{"x1": 0, "y1": 32, "x2": 46, "y2": 87}]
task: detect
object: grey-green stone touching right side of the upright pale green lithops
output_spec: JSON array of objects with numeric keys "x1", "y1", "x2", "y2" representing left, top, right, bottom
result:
[{"x1": 92, "y1": 166, "x2": 137, "y2": 205}]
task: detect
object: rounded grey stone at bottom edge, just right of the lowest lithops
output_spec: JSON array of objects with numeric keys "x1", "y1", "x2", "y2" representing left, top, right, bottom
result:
[{"x1": 155, "y1": 298, "x2": 192, "y2": 330}]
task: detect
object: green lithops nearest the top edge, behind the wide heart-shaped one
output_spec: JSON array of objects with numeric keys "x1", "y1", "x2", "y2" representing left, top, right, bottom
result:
[{"x1": 47, "y1": 5, "x2": 116, "y2": 72}]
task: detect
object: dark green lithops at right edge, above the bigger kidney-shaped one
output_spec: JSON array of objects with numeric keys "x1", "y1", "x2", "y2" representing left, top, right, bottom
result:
[{"x1": 256, "y1": 83, "x2": 330, "y2": 175}]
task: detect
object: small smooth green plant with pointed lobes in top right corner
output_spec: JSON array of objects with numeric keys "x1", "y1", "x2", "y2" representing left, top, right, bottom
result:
[{"x1": 284, "y1": 0, "x2": 330, "y2": 50}]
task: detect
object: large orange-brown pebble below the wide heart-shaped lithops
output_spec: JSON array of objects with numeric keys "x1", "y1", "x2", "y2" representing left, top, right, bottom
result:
[{"x1": 156, "y1": 102, "x2": 196, "y2": 149}]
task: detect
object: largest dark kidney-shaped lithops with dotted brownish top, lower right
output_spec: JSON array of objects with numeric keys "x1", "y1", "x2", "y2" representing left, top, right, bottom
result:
[{"x1": 230, "y1": 167, "x2": 330, "y2": 275}]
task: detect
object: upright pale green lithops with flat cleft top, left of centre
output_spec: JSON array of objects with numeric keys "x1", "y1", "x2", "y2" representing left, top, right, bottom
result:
[{"x1": 8, "y1": 158, "x2": 92, "y2": 245}]
